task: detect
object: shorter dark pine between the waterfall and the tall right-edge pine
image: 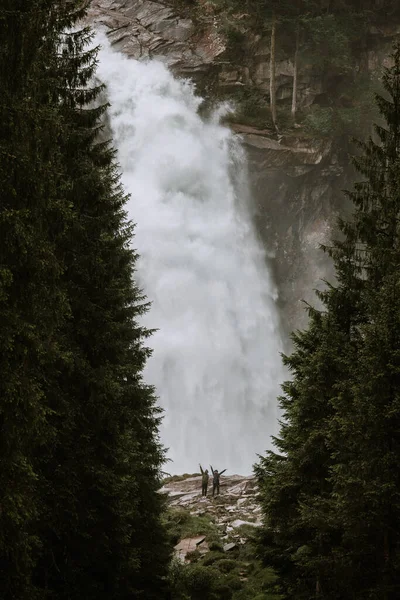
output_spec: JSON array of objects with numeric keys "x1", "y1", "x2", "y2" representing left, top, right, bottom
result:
[{"x1": 256, "y1": 288, "x2": 362, "y2": 600}]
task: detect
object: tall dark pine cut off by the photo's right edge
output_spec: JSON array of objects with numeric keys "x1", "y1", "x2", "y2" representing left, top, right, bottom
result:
[{"x1": 326, "y1": 47, "x2": 400, "y2": 599}]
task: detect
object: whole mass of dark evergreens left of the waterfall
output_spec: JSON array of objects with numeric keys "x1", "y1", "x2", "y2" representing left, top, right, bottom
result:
[{"x1": 0, "y1": 0, "x2": 169, "y2": 600}]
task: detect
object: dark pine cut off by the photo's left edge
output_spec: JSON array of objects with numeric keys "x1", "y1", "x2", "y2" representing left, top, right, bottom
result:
[{"x1": 0, "y1": 0, "x2": 70, "y2": 600}]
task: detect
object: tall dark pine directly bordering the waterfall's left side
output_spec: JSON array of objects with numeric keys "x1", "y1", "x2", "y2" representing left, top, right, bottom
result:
[{"x1": 28, "y1": 5, "x2": 169, "y2": 600}]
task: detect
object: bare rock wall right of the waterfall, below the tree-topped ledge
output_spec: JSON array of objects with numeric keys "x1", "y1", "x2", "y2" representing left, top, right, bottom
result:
[{"x1": 233, "y1": 125, "x2": 342, "y2": 333}]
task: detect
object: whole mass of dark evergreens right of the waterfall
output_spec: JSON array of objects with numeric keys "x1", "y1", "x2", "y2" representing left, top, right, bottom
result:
[{"x1": 256, "y1": 47, "x2": 400, "y2": 600}]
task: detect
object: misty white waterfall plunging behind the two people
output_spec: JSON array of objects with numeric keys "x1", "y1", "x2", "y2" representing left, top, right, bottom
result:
[{"x1": 96, "y1": 34, "x2": 283, "y2": 474}]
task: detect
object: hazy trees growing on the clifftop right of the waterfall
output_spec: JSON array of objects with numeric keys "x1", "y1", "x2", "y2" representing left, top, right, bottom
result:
[{"x1": 207, "y1": 0, "x2": 400, "y2": 135}]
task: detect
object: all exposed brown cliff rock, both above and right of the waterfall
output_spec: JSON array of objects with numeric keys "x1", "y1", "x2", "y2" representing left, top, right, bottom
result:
[{"x1": 88, "y1": 0, "x2": 399, "y2": 330}]
